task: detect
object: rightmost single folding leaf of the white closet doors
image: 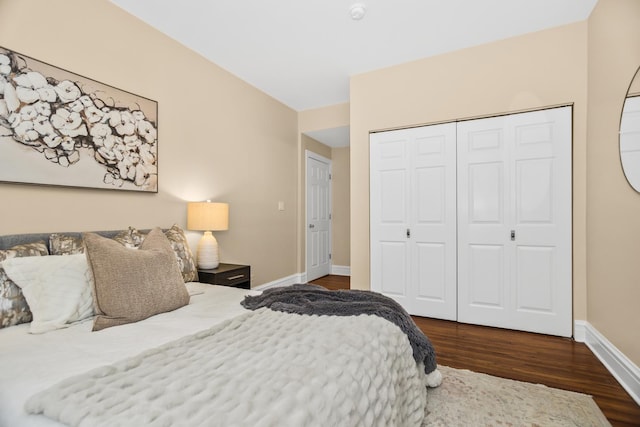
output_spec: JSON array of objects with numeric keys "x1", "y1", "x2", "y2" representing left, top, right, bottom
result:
[{"x1": 507, "y1": 107, "x2": 573, "y2": 337}]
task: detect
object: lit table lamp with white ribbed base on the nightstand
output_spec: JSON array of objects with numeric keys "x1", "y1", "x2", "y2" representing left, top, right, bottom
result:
[{"x1": 187, "y1": 200, "x2": 229, "y2": 269}]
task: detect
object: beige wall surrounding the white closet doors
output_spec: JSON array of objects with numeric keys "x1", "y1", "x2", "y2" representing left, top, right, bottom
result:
[{"x1": 351, "y1": 22, "x2": 587, "y2": 332}]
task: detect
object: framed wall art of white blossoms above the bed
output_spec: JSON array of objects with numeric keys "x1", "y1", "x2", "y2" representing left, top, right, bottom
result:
[{"x1": 0, "y1": 47, "x2": 158, "y2": 193}]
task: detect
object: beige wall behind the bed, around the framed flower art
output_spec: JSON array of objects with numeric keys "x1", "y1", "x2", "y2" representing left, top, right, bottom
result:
[{"x1": 0, "y1": 0, "x2": 298, "y2": 286}]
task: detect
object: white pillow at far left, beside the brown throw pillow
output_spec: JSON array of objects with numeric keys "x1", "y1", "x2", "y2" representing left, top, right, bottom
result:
[{"x1": 2, "y1": 254, "x2": 94, "y2": 334}]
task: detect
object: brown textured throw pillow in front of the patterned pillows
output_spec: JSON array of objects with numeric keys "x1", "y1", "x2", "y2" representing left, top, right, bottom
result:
[{"x1": 83, "y1": 228, "x2": 189, "y2": 331}]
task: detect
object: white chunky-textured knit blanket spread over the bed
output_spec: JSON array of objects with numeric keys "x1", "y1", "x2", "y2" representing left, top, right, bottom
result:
[{"x1": 25, "y1": 309, "x2": 427, "y2": 427}]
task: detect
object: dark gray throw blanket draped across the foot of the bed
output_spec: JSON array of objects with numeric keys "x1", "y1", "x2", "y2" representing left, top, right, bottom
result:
[{"x1": 240, "y1": 284, "x2": 438, "y2": 374}]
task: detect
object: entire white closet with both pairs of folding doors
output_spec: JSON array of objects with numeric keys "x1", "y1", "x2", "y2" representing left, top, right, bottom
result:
[{"x1": 370, "y1": 107, "x2": 572, "y2": 336}]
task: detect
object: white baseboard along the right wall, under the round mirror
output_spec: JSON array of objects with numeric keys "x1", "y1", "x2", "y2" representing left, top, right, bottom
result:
[{"x1": 574, "y1": 320, "x2": 640, "y2": 405}]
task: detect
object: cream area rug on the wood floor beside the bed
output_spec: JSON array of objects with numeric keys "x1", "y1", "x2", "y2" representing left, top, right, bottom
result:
[{"x1": 422, "y1": 366, "x2": 611, "y2": 427}]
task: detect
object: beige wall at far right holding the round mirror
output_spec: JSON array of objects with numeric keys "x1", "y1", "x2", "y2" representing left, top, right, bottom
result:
[{"x1": 587, "y1": 0, "x2": 640, "y2": 366}]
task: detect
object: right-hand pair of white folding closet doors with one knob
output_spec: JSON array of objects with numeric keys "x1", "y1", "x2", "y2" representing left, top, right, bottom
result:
[{"x1": 458, "y1": 107, "x2": 572, "y2": 336}]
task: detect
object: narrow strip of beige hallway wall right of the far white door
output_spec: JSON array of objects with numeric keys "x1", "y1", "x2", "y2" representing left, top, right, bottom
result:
[{"x1": 331, "y1": 147, "x2": 351, "y2": 267}]
